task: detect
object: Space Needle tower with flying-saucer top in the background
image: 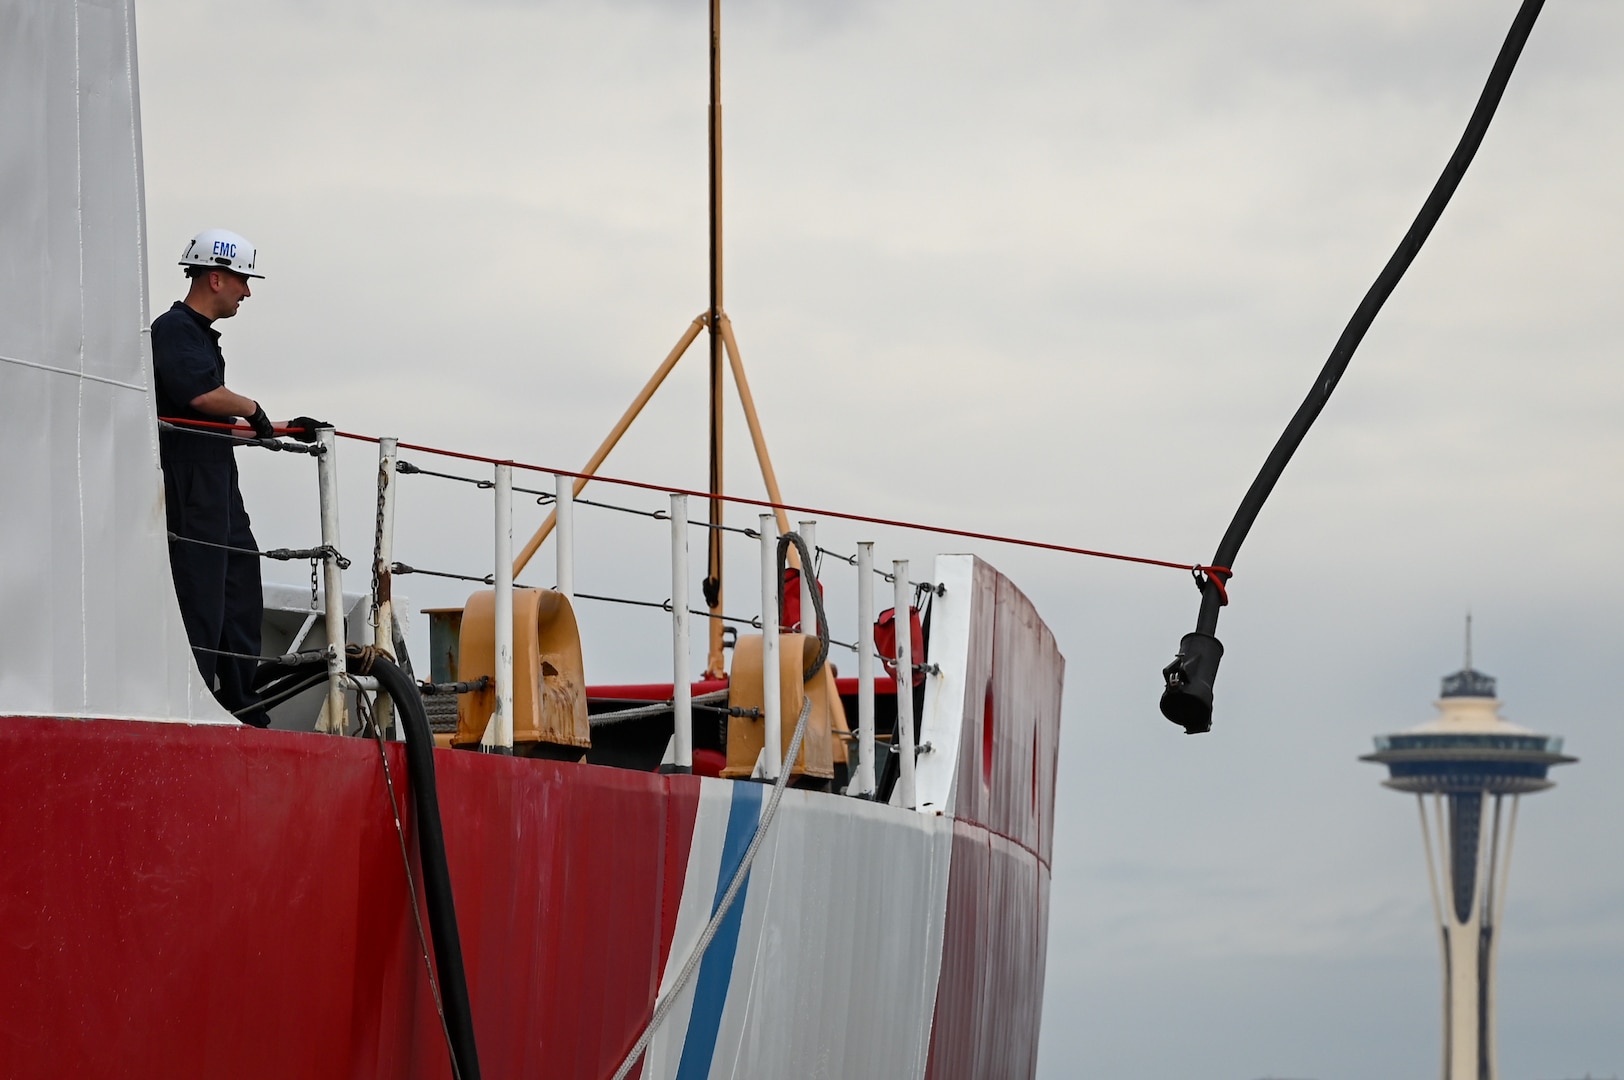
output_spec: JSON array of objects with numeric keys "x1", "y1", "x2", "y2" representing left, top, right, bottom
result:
[{"x1": 1359, "y1": 617, "x2": 1577, "y2": 1080}]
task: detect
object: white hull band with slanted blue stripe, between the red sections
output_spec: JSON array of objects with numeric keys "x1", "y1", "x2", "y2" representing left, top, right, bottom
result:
[{"x1": 643, "y1": 780, "x2": 952, "y2": 1080}]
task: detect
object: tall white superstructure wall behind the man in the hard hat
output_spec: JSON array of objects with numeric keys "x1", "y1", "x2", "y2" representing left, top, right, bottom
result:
[{"x1": 0, "y1": 2, "x2": 231, "y2": 723}]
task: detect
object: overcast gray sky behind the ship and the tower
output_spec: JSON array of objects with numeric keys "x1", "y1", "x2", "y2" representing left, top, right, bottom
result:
[{"x1": 138, "y1": 0, "x2": 1624, "y2": 1080}]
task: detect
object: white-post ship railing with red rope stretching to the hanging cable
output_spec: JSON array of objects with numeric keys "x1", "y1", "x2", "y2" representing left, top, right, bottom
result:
[{"x1": 162, "y1": 404, "x2": 1208, "y2": 807}]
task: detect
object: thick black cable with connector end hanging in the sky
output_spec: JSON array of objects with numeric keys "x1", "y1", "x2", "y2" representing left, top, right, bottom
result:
[{"x1": 1161, "y1": 0, "x2": 1544, "y2": 734}]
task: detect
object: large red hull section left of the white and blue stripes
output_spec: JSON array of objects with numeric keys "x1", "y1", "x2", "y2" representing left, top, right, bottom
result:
[{"x1": 0, "y1": 719, "x2": 698, "y2": 1080}]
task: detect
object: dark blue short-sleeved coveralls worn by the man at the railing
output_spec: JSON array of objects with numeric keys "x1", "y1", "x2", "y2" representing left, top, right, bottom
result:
[{"x1": 153, "y1": 300, "x2": 270, "y2": 728}]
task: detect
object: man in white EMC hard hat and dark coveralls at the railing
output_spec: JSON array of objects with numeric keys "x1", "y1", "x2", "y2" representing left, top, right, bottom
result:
[{"x1": 153, "y1": 229, "x2": 320, "y2": 728}]
